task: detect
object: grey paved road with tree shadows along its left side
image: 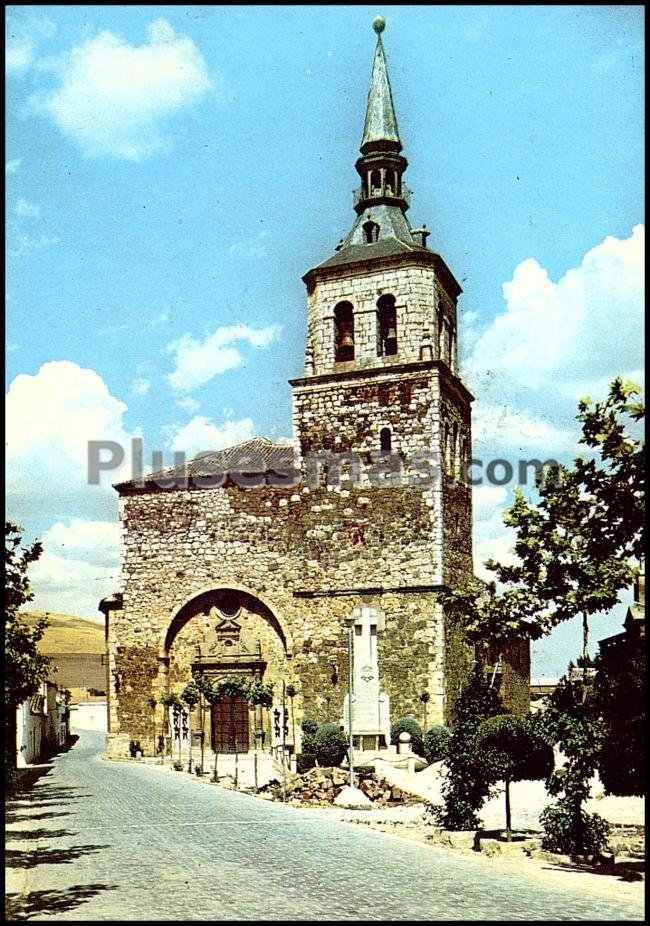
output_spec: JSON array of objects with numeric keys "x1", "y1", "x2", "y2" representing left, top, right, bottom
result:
[{"x1": 7, "y1": 732, "x2": 643, "y2": 921}]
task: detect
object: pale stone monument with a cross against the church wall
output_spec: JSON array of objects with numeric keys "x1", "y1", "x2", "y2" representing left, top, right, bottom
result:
[{"x1": 343, "y1": 607, "x2": 390, "y2": 751}]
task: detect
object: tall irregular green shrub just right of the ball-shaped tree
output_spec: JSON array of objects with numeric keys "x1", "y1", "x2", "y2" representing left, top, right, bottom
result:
[{"x1": 540, "y1": 666, "x2": 609, "y2": 856}]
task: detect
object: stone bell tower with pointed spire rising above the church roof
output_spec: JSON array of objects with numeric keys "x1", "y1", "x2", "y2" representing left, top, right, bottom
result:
[{"x1": 291, "y1": 18, "x2": 472, "y2": 582}]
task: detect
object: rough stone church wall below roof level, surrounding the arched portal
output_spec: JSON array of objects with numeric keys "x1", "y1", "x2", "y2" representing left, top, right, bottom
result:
[{"x1": 109, "y1": 486, "x2": 444, "y2": 745}]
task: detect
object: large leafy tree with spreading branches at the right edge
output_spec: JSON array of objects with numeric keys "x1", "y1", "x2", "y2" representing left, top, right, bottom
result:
[{"x1": 442, "y1": 379, "x2": 645, "y2": 659}]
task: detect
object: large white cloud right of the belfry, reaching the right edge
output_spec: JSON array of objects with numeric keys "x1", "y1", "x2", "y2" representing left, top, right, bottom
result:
[{"x1": 467, "y1": 225, "x2": 645, "y2": 399}]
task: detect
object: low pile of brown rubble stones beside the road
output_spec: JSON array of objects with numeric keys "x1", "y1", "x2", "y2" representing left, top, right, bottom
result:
[{"x1": 264, "y1": 768, "x2": 420, "y2": 807}]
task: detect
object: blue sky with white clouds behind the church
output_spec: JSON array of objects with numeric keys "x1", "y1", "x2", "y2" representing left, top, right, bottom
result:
[{"x1": 6, "y1": 6, "x2": 644, "y2": 675}]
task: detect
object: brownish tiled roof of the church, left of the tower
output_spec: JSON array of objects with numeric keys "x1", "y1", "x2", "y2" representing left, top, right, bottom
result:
[{"x1": 114, "y1": 437, "x2": 294, "y2": 492}]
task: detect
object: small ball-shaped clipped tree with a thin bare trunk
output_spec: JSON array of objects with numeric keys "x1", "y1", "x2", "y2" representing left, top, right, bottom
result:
[{"x1": 477, "y1": 714, "x2": 553, "y2": 842}]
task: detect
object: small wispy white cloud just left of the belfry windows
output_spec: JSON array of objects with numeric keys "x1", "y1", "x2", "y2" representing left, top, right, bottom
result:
[{"x1": 167, "y1": 325, "x2": 279, "y2": 392}]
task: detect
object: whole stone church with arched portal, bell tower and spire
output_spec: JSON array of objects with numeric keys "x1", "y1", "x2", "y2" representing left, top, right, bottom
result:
[{"x1": 100, "y1": 18, "x2": 530, "y2": 756}]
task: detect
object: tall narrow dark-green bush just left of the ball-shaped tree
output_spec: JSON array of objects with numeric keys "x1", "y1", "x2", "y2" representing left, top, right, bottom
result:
[{"x1": 432, "y1": 661, "x2": 503, "y2": 830}]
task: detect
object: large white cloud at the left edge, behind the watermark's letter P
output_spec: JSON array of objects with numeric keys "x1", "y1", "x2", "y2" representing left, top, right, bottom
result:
[{"x1": 6, "y1": 360, "x2": 137, "y2": 524}]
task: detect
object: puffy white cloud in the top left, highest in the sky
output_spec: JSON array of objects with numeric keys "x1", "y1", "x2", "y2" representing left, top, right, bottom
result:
[{"x1": 32, "y1": 19, "x2": 211, "y2": 161}]
